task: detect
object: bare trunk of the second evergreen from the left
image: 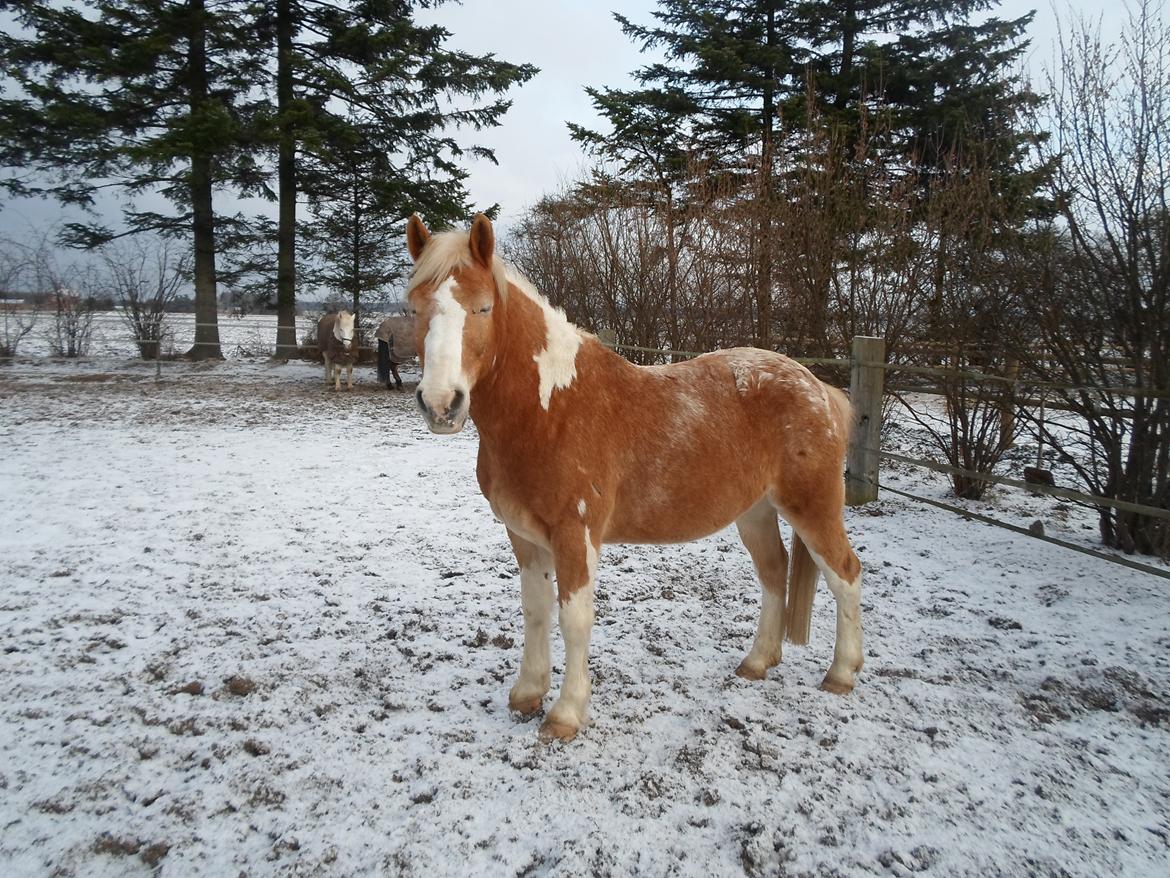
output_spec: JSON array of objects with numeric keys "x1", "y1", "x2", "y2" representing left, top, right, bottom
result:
[{"x1": 276, "y1": 0, "x2": 297, "y2": 359}]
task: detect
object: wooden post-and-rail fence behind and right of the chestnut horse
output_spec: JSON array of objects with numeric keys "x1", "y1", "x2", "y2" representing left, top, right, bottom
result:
[{"x1": 598, "y1": 330, "x2": 1170, "y2": 579}]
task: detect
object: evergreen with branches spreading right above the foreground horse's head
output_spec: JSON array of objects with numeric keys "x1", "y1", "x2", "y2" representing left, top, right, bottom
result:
[{"x1": 268, "y1": 0, "x2": 537, "y2": 354}]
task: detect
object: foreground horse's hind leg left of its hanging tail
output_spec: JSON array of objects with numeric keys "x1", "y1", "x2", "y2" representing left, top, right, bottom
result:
[{"x1": 735, "y1": 501, "x2": 789, "y2": 680}]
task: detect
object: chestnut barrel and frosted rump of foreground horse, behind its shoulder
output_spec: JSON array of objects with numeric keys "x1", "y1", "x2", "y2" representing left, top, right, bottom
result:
[{"x1": 580, "y1": 348, "x2": 848, "y2": 542}]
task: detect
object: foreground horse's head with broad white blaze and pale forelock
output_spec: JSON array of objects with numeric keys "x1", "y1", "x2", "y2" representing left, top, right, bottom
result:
[{"x1": 406, "y1": 213, "x2": 508, "y2": 433}]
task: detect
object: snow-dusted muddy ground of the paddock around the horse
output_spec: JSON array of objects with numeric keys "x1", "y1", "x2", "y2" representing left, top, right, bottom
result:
[{"x1": 0, "y1": 359, "x2": 1170, "y2": 878}]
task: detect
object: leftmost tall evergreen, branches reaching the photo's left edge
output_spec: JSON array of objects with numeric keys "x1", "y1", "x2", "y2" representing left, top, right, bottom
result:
[{"x1": 0, "y1": 0, "x2": 261, "y2": 358}]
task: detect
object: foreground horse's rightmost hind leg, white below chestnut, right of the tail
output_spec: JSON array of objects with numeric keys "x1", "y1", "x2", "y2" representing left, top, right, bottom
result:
[{"x1": 785, "y1": 508, "x2": 863, "y2": 695}]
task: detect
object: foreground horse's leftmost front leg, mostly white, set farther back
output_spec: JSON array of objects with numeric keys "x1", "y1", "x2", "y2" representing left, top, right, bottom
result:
[{"x1": 508, "y1": 530, "x2": 556, "y2": 715}]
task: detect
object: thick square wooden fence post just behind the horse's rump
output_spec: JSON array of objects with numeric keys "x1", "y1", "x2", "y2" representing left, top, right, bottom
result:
[{"x1": 845, "y1": 335, "x2": 886, "y2": 506}]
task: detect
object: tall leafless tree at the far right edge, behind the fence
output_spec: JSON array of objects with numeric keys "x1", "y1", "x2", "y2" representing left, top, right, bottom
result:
[{"x1": 1025, "y1": 0, "x2": 1170, "y2": 557}]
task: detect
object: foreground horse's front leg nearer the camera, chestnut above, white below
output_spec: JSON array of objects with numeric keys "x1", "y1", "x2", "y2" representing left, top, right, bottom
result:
[{"x1": 541, "y1": 523, "x2": 601, "y2": 741}]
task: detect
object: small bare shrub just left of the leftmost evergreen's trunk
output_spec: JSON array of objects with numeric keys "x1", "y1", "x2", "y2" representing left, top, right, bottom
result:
[{"x1": 102, "y1": 239, "x2": 191, "y2": 359}]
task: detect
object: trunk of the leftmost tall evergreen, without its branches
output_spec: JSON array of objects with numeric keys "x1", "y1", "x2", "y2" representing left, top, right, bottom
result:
[{"x1": 187, "y1": 0, "x2": 223, "y2": 359}]
